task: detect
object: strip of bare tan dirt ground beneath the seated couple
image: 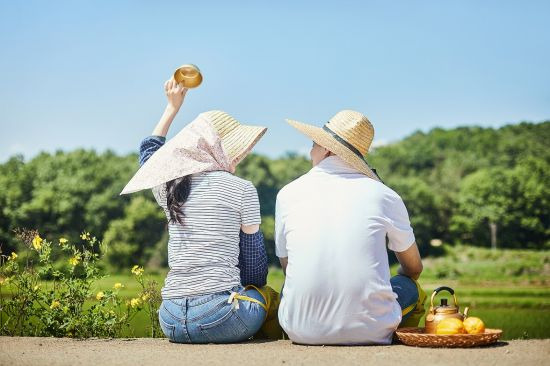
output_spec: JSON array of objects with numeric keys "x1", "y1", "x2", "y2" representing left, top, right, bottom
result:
[{"x1": 0, "y1": 337, "x2": 550, "y2": 366}]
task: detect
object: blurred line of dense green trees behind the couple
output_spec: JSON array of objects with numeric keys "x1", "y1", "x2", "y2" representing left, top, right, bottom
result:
[{"x1": 0, "y1": 121, "x2": 550, "y2": 268}]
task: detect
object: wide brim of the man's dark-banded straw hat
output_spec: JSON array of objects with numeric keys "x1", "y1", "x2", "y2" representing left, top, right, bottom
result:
[{"x1": 286, "y1": 119, "x2": 380, "y2": 182}]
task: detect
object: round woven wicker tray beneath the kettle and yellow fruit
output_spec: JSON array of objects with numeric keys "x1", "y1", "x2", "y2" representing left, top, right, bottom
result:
[{"x1": 395, "y1": 328, "x2": 502, "y2": 348}]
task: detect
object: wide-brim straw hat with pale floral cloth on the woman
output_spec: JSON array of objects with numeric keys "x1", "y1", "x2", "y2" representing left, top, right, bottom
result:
[{"x1": 120, "y1": 111, "x2": 267, "y2": 194}]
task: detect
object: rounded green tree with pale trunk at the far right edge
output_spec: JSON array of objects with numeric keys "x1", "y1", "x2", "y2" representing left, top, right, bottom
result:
[{"x1": 452, "y1": 157, "x2": 550, "y2": 248}]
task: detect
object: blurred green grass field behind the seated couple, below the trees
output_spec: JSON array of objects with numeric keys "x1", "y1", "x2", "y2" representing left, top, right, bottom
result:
[{"x1": 2, "y1": 247, "x2": 550, "y2": 339}]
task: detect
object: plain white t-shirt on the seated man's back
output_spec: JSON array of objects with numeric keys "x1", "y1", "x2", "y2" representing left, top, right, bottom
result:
[{"x1": 275, "y1": 156, "x2": 415, "y2": 344}]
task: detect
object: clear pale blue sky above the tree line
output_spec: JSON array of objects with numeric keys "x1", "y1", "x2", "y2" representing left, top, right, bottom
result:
[{"x1": 0, "y1": 0, "x2": 550, "y2": 161}]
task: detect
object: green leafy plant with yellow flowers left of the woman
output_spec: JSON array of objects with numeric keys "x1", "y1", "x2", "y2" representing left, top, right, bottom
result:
[{"x1": 0, "y1": 230, "x2": 162, "y2": 338}]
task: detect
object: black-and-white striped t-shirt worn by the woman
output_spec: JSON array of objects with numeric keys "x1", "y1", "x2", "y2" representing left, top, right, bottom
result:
[{"x1": 153, "y1": 171, "x2": 261, "y2": 299}]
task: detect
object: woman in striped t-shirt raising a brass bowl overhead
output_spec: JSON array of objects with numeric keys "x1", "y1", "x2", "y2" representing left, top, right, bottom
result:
[{"x1": 122, "y1": 80, "x2": 276, "y2": 343}]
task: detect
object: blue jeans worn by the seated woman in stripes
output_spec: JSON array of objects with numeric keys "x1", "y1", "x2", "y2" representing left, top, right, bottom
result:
[{"x1": 159, "y1": 286, "x2": 266, "y2": 343}]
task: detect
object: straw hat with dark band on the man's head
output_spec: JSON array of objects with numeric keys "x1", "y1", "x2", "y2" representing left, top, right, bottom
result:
[{"x1": 287, "y1": 110, "x2": 380, "y2": 181}]
